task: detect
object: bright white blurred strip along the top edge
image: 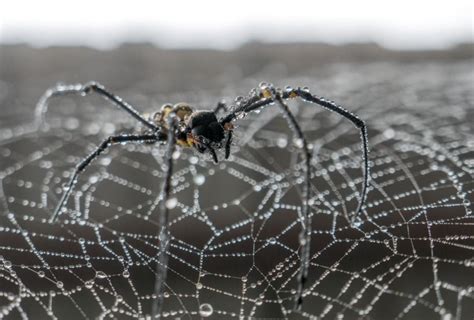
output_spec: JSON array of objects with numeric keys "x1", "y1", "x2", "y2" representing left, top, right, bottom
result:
[{"x1": 0, "y1": 0, "x2": 473, "y2": 50}]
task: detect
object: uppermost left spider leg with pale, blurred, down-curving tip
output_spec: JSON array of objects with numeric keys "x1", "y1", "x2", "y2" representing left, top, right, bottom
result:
[{"x1": 35, "y1": 82, "x2": 158, "y2": 131}]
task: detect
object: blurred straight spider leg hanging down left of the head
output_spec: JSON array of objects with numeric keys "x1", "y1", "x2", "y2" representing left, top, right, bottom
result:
[{"x1": 152, "y1": 114, "x2": 177, "y2": 318}]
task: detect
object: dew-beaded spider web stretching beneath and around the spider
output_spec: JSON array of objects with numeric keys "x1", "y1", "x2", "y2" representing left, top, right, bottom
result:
[{"x1": 0, "y1": 63, "x2": 474, "y2": 319}]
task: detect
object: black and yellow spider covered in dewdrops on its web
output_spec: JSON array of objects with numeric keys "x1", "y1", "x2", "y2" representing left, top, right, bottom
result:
[{"x1": 35, "y1": 82, "x2": 369, "y2": 316}]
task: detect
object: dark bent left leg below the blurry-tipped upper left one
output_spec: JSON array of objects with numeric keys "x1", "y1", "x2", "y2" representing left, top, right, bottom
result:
[{"x1": 49, "y1": 134, "x2": 159, "y2": 223}]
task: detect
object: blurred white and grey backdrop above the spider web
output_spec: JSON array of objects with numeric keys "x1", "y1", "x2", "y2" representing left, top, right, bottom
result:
[{"x1": 0, "y1": 0, "x2": 473, "y2": 116}]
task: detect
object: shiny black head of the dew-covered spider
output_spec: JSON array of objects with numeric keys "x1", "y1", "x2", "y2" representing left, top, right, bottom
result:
[{"x1": 186, "y1": 111, "x2": 225, "y2": 153}]
